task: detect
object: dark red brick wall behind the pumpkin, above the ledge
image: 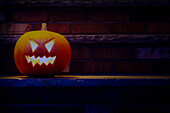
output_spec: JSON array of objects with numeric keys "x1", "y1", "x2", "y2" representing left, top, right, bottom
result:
[{"x1": 0, "y1": 0, "x2": 170, "y2": 75}]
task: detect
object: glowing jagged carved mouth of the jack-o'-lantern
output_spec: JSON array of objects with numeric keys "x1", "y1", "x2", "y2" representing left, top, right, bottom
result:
[{"x1": 25, "y1": 55, "x2": 56, "y2": 67}]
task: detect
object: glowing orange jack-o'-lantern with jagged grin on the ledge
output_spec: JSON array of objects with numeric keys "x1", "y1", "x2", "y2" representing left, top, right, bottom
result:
[{"x1": 14, "y1": 23, "x2": 71, "y2": 76}]
